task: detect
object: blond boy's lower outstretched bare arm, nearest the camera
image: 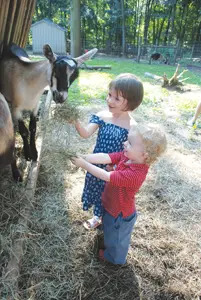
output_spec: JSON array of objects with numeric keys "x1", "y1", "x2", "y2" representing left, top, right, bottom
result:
[{"x1": 73, "y1": 154, "x2": 111, "y2": 181}]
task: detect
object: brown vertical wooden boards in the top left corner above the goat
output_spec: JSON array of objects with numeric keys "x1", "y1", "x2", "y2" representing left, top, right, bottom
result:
[{"x1": 0, "y1": 0, "x2": 36, "y2": 52}]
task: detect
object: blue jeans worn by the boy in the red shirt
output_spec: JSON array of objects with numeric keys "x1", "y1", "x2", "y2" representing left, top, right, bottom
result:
[{"x1": 103, "y1": 210, "x2": 137, "y2": 264}]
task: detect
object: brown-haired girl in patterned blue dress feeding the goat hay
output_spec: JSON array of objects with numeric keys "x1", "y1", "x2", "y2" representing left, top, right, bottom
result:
[{"x1": 75, "y1": 73, "x2": 144, "y2": 229}]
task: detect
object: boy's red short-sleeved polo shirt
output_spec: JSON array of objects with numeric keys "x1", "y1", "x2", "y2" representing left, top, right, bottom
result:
[{"x1": 102, "y1": 152, "x2": 149, "y2": 218}]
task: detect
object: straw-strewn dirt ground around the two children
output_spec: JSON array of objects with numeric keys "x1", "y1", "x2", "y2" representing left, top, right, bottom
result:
[{"x1": 0, "y1": 83, "x2": 201, "y2": 300}]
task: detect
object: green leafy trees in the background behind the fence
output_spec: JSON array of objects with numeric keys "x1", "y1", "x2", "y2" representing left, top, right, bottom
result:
[{"x1": 33, "y1": 0, "x2": 201, "y2": 56}]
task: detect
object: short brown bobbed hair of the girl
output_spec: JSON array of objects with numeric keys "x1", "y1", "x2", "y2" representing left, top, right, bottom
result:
[{"x1": 109, "y1": 73, "x2": 144, "y2": 111}]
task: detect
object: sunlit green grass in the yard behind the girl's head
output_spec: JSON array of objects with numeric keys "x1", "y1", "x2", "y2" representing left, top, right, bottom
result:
[{"x1": 66, "y1": 58, "x2": 201, "y2": 124}]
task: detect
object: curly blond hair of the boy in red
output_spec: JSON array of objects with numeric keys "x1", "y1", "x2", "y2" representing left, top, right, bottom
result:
[{"x1": 130, "y1": 124, "x2": 167, "y2": 164}]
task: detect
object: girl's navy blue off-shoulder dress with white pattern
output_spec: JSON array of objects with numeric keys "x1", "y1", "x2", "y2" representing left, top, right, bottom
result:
[{"x1": 82, "y1": 115, "x2": 128, "y2": 217}]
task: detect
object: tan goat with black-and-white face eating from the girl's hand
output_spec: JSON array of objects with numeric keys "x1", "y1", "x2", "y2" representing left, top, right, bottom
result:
[{"x1": 0, "y1": 44, "x2": 98, "y2": 161}]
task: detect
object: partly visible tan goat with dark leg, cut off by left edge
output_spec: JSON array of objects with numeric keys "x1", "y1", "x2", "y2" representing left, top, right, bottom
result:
[{"x1": 0, "y1": 93, "x2": 22, "y2": 181}]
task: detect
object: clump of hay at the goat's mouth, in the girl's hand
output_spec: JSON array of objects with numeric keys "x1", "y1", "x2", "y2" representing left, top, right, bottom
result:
[{"x1": 53, "y1": 102, "x2": 81, "y2": 123}]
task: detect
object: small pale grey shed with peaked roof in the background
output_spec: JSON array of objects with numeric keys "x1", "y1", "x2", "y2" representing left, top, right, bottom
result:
[{"x1": 31, "y1": 19, "x2": 66, "y2": 54}]
